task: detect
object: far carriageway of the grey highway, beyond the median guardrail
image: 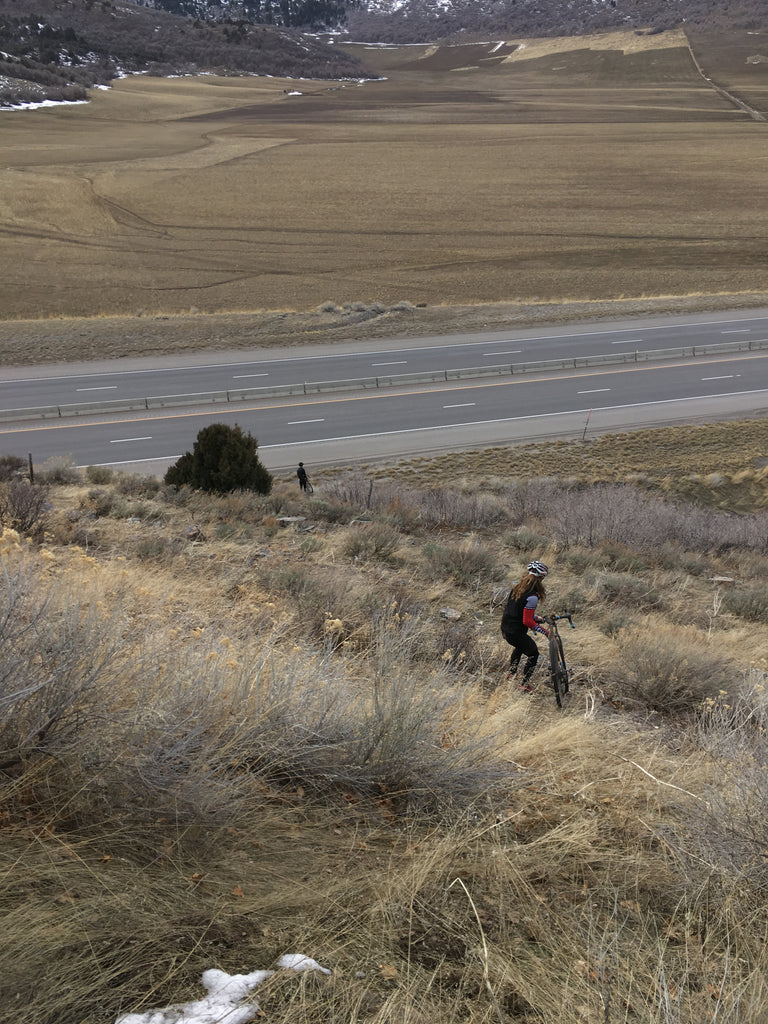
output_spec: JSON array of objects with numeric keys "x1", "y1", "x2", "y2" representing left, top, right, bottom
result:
[{"x1": 0, "y1": 311, "x2": 768, "y2": 410}]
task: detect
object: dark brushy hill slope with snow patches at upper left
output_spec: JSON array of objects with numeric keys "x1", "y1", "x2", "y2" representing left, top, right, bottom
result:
[{"x1": 0, "y1": 0, "x2": 365, "y2": 105}]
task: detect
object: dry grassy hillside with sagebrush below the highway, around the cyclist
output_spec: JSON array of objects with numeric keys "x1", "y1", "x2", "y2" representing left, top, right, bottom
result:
[{"x1": 0, "y1": 422, "x2": 768, "y2": 1024}]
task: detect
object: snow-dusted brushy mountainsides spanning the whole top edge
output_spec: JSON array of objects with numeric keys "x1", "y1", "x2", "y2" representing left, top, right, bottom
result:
[{"x1": 0, "y1": 0, "x2": 766, "y2": 105}]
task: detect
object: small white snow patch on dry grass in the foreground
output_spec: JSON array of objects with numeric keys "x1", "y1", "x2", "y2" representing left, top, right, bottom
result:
[{"x1": 115, "y1": 953, "x2": 331, "y2": 1024}]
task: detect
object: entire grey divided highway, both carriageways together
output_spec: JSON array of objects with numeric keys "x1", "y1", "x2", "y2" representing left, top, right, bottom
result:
[{"x1": 0, "y1": 311, "x2": 768, "y2": 473}]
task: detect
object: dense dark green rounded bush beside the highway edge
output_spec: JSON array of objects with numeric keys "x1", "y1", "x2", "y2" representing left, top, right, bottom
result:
[{"x1": 164, "y1": 423, "x2": 272, "y2": 495}]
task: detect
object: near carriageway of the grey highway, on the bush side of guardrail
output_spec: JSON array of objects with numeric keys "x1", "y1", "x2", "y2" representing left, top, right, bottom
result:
[{"x1": 0, "y1": 342, "x2": 768, "y2": 473}]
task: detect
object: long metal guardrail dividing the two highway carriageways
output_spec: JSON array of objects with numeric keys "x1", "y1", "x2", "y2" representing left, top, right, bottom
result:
[{"x1": 0, "y1": 338, "x2": 768, "y2": 423}]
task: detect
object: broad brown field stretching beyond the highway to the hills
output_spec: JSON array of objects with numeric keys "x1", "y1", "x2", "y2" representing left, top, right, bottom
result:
[{"x1": 0, "y1": 27, "x2": 768, "y2": 339}]
